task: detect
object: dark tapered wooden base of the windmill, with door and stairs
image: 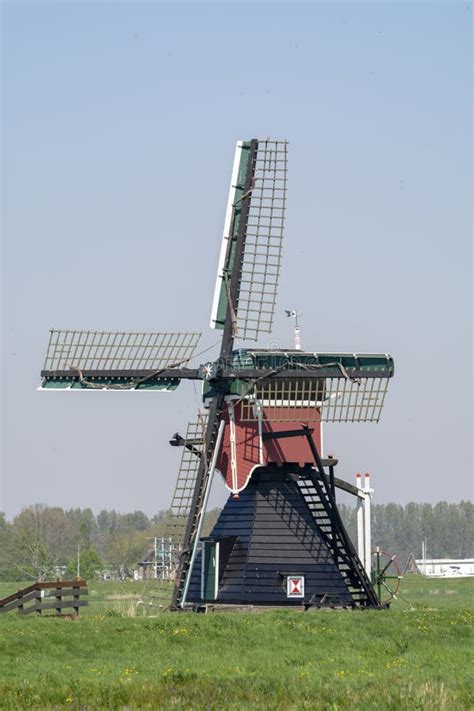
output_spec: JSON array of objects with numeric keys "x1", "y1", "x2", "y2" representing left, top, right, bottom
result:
[{"x1": 186, "y1": 464, "x2": 380, "y2": 609}]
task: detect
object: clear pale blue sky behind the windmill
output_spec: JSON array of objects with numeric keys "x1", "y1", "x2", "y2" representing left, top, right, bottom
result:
[{"x1": 0, "y1": 2, "x2": 472, "y2": 517}]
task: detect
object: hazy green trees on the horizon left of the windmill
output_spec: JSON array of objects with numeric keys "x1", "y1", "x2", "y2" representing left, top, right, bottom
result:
[{"x1": 0, "y1": 504, "x2": 219, "y2": 581}]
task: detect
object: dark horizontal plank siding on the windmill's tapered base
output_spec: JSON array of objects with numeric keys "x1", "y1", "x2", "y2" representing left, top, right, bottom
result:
[{"x1": 188, "y1": 468, "x2": 353, "y2": 605}]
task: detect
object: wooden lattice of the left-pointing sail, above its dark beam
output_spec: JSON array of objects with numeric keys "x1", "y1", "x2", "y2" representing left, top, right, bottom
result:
[{"x1": 43, "y1": 329, "x2": 201, "y2": 371}]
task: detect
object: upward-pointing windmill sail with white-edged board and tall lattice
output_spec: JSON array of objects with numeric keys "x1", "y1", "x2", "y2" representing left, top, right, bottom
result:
[{"x1": 210, "y1": 140, "x2": 288, "y2": 341}]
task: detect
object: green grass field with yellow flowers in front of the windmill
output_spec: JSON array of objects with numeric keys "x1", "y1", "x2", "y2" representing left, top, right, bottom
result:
[{"x1": 0, "y1": 576, "x2": 474, "y2": 711}]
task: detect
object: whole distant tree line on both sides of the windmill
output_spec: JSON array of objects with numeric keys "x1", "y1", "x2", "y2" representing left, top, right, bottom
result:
[{"x1": 0, "y1": 501, "x2": 474, "y2": 581}]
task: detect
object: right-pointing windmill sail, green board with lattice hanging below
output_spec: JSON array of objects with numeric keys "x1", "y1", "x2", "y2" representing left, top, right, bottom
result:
[{"x1": 221, "y1": 350, "x2": 394, "y2": 422}]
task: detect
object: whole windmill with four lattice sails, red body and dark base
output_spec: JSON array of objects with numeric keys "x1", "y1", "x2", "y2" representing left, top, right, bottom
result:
[{"x1": 41, "y1": 139, "x2": 394, "y2": 609}]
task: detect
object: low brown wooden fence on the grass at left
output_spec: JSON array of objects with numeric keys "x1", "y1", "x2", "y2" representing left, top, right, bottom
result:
[{"x1": 0, "y1": 580, "x2": 88, "y2": 617}]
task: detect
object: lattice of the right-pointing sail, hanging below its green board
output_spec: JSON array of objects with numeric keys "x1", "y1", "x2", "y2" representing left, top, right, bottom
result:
[{"x1": 241, "y1": 377, "x2": 389, "y2": 422}]
